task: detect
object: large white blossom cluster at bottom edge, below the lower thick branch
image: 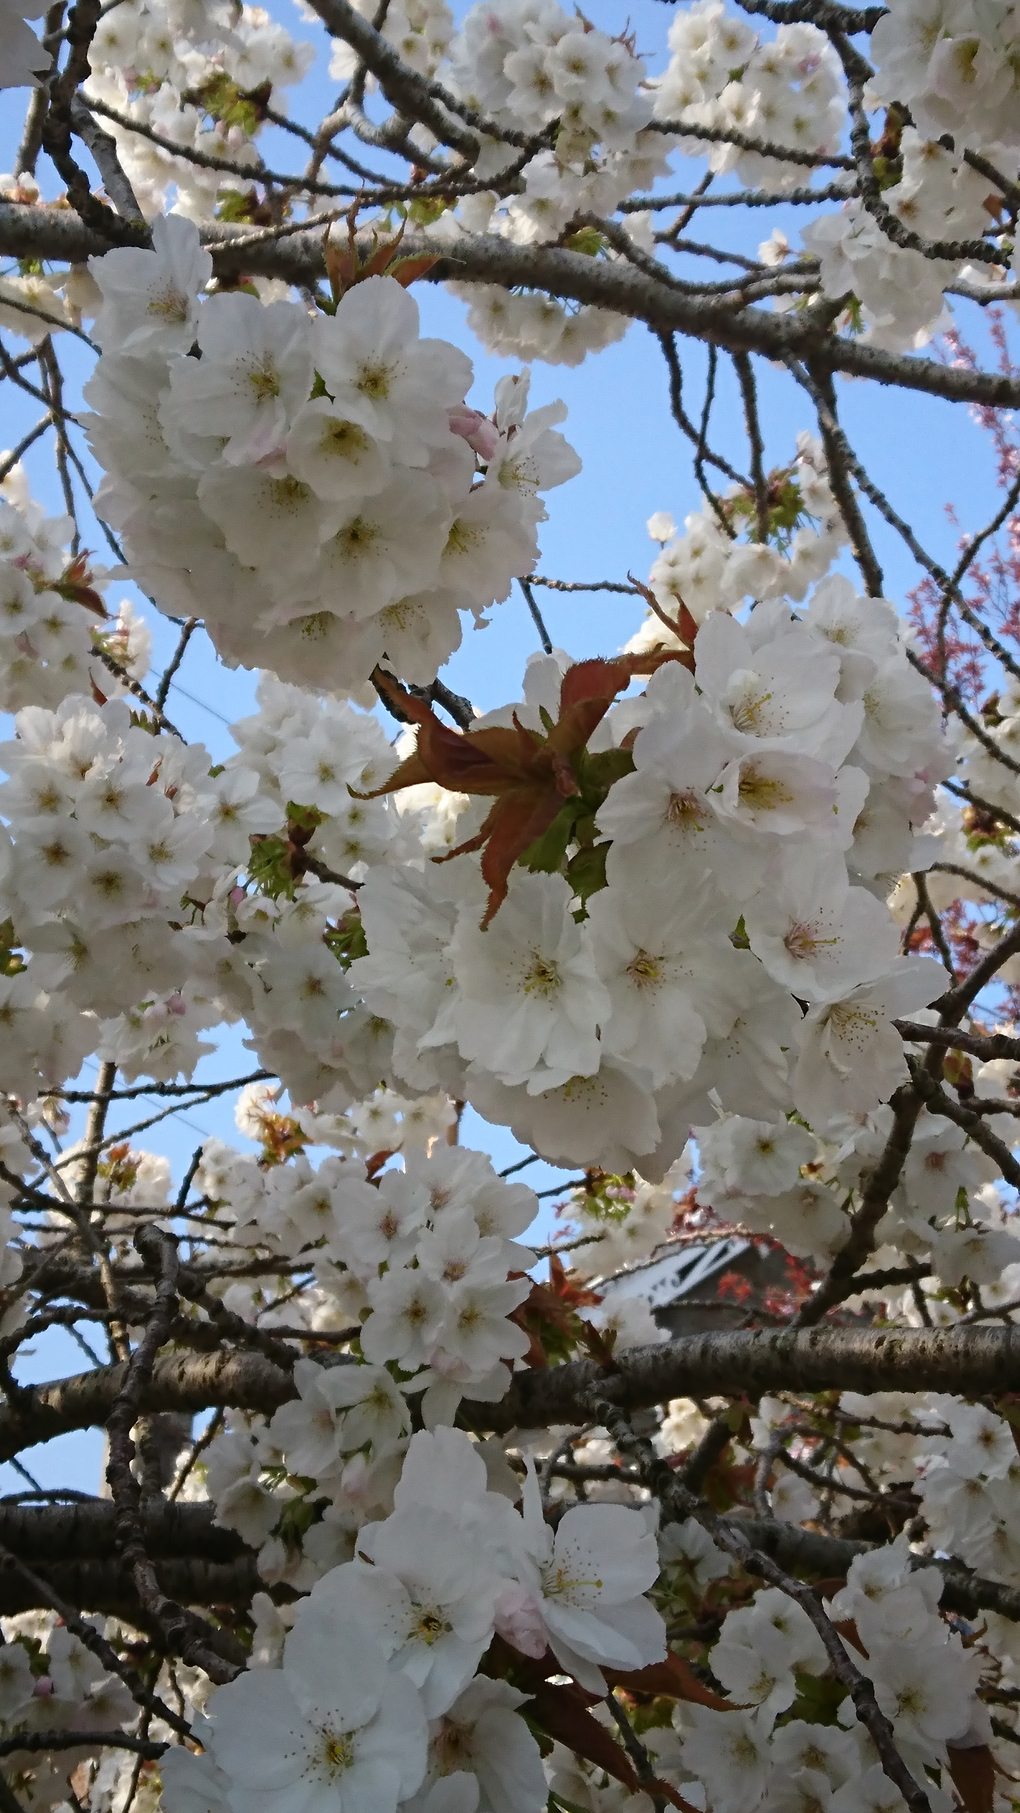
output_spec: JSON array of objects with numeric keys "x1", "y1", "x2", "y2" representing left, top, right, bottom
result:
[{"x1": 163, "y1": 1421, "x2": 665, "y2": 1813}]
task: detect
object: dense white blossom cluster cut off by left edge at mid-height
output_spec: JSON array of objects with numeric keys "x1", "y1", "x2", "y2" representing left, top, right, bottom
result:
[{"x1": 0, "y1": 694, "x2": 251, "y2": 1100}]
